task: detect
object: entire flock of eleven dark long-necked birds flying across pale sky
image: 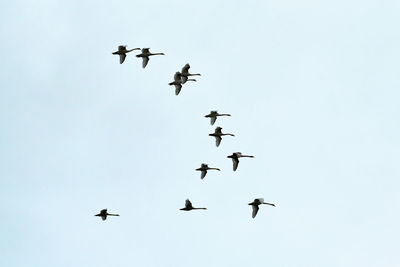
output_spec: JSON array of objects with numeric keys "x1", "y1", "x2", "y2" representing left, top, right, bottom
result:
[{"x1": 95, "y1": 45, "x2": 275, "y2": 221}]
